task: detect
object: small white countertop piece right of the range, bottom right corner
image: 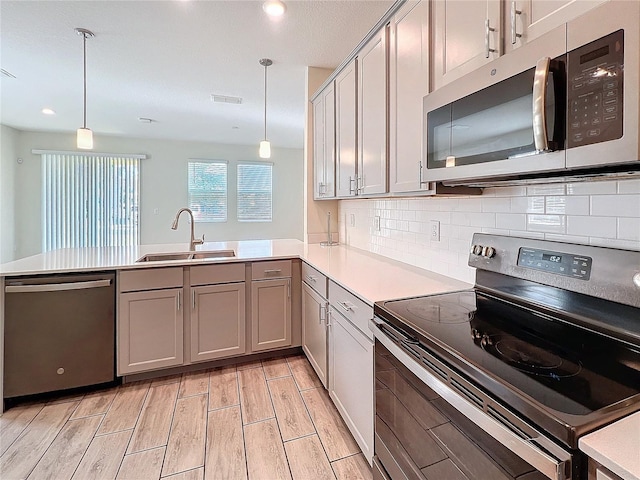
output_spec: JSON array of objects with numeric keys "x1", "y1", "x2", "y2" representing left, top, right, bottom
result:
[{"x1": 578, "y1": 412, "x2": 640, "y2": 480}]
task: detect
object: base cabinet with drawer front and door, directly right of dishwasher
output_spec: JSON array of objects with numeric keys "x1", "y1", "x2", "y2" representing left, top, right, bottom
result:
[{"x1": 117, "y1": 267, "x2": 184, "y2": 375}]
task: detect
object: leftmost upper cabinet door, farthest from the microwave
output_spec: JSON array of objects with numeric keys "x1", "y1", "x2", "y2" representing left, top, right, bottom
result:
[{"x1": 313, "y1": 82, "x2": 336, "y2": 200}]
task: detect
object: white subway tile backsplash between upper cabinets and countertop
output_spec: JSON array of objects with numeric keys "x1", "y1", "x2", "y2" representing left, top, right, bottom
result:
[{"x1": 340, "y1": 180, "x2": 640, "y2": 283}]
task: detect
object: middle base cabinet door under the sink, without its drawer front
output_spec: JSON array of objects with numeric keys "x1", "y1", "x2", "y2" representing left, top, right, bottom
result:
[{"x1": 191, "y1": 282, "x2": 246, "y2": 362}]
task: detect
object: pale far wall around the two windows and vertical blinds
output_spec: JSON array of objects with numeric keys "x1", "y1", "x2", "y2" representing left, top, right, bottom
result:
[{"x1": 10, "y1": 132, "x2": 304, "y2": 258}]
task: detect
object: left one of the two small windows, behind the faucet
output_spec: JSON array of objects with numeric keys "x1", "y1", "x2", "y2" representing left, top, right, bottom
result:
[{"x1": 188, "y1": 160, "x2": 227, "y2": 222}]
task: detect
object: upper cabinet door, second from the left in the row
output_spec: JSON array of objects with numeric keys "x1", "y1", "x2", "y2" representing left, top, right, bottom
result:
[{"x1": 335, "y1": 59, "x2": 357, "y2": 197}]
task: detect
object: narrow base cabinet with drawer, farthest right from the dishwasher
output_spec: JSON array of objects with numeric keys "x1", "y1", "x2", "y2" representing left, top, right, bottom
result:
[{"x1": 251, "y1": 260, "x2": 292, "y2": 352}]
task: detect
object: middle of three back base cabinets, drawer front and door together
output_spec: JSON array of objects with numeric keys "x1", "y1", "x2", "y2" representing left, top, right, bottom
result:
[{"x1": 189, "y1": 263, "x2": 246, "y2": 362}]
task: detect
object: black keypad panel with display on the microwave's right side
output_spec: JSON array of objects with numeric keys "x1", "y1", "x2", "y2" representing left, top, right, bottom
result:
[{"x1": 567, "y1": 30, "x2": 624, "y2": 148}]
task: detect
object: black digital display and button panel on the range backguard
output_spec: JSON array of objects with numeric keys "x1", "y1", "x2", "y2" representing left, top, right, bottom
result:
[{"x1": 518, "y1": 247, "x2": 593, "y2": 280}]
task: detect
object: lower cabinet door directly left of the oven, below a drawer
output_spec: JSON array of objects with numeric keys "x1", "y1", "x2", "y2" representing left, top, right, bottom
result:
[{"x1": 329, "y1": 307, "x2": 374, "y2": 464}]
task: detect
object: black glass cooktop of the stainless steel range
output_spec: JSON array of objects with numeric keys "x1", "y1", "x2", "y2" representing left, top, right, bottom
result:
[{"x1": 374, "y1": 290, "x2": 640, "y2": 444}]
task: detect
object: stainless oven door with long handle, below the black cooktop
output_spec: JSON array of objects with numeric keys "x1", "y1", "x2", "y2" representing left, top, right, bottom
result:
[{"x1": 372, "y1": 319, "x2": 577, "y2": 480}]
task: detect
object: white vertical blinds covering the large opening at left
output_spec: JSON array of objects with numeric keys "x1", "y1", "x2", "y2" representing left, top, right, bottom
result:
[{"x1": 42, "y1": 153, "x2": 140, "y2": 252}]
